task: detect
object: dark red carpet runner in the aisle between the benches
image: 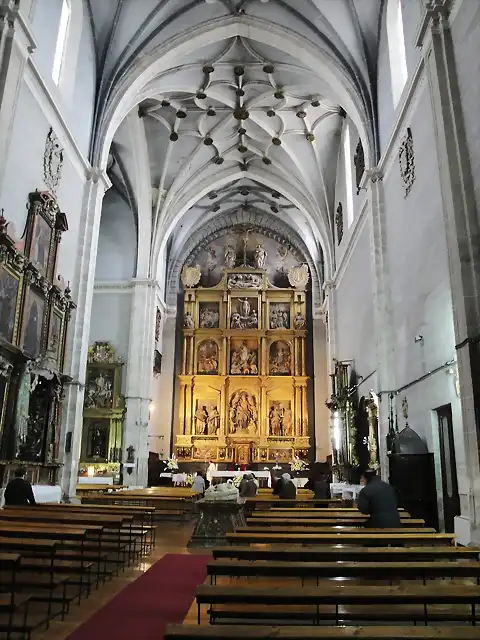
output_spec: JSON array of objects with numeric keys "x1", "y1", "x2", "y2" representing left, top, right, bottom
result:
[{"x1": 68, "y1": 554, "x2": 210, "y2": 640}]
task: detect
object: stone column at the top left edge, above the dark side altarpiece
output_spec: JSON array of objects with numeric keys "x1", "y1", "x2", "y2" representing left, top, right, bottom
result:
[{"x1": 0, "y1": 0, "x2": 37, "y2": 195}]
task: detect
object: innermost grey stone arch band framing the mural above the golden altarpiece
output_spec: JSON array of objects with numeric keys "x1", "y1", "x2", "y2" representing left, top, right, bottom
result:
[{"x1": 166, "y1": 209, "x2": 323, "y2": 307}]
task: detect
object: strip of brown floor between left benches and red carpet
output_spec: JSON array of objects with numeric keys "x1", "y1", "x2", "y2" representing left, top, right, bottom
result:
[{"x1": 33, "y1": 522, "x2": 205, "y2": 640}]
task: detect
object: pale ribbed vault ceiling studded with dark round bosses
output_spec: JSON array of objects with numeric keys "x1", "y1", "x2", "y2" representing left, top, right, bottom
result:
[{"x1": 89, "y1": 0, "x2": 382, "y2": 310}]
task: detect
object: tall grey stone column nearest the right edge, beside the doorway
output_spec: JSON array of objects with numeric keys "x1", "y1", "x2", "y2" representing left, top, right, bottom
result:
[{"x1": 417, "y1": 5, "x2": 480, "y2": 541}]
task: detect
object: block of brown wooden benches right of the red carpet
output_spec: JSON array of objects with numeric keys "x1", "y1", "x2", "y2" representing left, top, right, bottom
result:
[{"x1": 165, "y1": 507, "x2": 480, "y2": 640}]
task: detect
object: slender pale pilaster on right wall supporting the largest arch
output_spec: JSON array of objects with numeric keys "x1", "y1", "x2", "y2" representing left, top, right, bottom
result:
[{"x1": 364, "y1": 169, "x2": 395, "y2": 479}]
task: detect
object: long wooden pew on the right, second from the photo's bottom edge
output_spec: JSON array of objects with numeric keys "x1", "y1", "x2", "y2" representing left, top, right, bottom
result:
[{"x1": 196, "y1": 583, "x2": 480, "y2": 624}]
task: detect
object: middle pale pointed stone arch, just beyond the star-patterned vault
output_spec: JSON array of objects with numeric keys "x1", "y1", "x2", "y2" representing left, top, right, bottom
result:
[{"x1": 151, "y1": 168, "x2": 333, "y2": 279}]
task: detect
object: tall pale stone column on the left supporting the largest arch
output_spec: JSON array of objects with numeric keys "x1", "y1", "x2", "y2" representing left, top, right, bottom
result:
[{"x1": 60, "y1": 169, "x2": 110, "y2": 497}]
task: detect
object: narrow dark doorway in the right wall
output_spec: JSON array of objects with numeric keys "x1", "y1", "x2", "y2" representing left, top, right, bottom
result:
[{"x1": 437, "y1": 404, "x2": 460, "y2": 533}]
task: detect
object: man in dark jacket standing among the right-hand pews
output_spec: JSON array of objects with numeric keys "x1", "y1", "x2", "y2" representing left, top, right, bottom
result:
[{"x1": 357, "y1": 469, "x2": 402, "y2": 529}]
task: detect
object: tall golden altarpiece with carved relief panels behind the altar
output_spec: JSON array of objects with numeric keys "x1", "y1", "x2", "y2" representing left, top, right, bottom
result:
[{"x1": 175, "y1": 262, "x2": 310, "y2": 464}]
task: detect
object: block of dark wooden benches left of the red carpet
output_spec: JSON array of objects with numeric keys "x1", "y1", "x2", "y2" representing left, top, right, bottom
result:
[{"x1": 0, "y1": 504, "x2": 155, "y2": 638}]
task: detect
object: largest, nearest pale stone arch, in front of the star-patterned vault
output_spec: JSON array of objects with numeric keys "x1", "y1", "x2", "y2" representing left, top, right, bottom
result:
[{"x1": 92, "y1": 15, "x2": 376, "y2": 168}]
